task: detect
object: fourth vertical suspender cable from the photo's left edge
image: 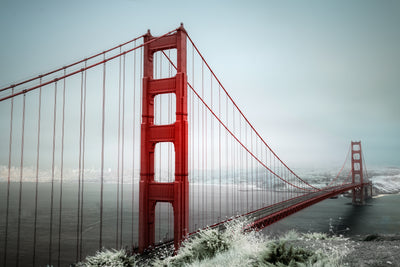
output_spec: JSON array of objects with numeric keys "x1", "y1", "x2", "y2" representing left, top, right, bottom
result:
[{"x1": 49, "y1": 81, "x2": 57, "y2": 264}]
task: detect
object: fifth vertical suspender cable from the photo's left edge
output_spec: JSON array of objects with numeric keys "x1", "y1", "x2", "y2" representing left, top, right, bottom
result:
[{"x1": 57, "y1": 69, "x2": 66, "y2": 266}]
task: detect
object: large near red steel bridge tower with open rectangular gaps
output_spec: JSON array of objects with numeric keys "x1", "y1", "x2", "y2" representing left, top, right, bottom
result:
[{"x1": 139, "y1": 25, "x2": 189, "y2": 251}]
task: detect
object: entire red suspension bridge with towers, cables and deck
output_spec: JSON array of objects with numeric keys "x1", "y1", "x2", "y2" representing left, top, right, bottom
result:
[{"x1": 0, "y1": 25, "x2": 372, "y2": 266}]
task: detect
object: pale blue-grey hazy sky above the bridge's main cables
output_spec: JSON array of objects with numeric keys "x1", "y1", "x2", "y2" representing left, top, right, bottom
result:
[{"x1": 0, "y1": 0, "x2": 400, "y2": 170}]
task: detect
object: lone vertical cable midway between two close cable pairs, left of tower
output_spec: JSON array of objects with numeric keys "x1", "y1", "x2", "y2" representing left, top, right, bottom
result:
[{"x1": 99, "y1": 53, "x2": 106, "y2": 250}]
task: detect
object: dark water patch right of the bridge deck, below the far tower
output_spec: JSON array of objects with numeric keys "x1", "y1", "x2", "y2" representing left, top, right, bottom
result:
[{"x1": 263, "y1": 194, "x2": 400, "y2": 238}]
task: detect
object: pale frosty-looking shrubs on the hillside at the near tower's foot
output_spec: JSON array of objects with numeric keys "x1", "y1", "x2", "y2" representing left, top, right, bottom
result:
[{"x1": 73, "y1": 219, "x2": 354, "y2": 267}]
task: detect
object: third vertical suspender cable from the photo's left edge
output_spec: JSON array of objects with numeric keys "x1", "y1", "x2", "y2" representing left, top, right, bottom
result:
[{"x1": 32, "y1": 82, "x2": 42, "y2": 266}]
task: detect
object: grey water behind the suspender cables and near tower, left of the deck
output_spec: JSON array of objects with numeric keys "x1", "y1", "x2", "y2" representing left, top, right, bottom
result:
[{"x1": 0, "y1": 181, "x2": 296, "y2": 266}]
